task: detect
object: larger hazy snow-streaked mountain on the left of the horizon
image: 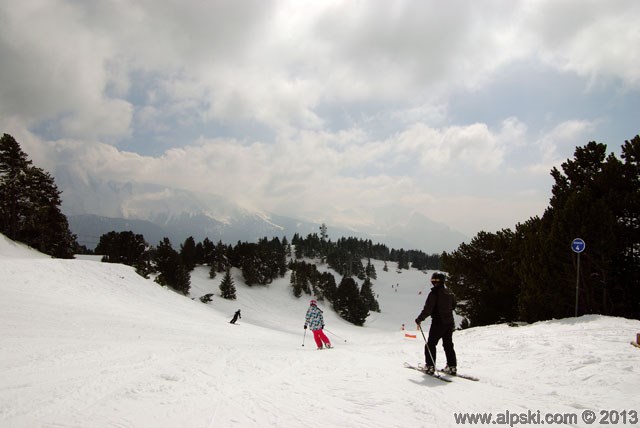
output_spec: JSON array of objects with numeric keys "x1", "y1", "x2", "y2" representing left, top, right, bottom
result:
[{"x1": 58, "y1": 168, "x2": 336, "y2": 248}]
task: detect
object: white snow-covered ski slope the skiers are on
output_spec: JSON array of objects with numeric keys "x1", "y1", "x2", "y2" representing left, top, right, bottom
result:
[{"x1": 0, "y1": 236, "x2": 640, "y2": 428}]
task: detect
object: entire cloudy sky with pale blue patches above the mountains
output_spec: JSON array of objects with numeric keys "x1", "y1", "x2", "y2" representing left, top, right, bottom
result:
[{"x1": 0, "y1": 0, "x2": 640, "y2": 236}]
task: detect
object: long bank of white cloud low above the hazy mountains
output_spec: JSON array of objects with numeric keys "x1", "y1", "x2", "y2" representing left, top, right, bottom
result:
[{"x1": 5, "y1": 115, "x2": 544, "y2": 233}]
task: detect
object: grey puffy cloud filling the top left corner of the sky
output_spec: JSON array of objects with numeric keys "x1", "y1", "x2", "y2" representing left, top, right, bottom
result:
[{"x1": 0, "y1": 0, "x2": 126, "y2": 136}]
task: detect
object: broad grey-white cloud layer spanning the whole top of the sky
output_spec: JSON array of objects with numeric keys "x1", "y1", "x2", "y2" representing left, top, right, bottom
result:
[{"x1": 0, "y1": 0, "x2": 640, "y2": 137}]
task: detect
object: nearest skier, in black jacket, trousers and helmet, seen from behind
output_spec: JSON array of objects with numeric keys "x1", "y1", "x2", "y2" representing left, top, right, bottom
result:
[{"x1": 416, "y1": 272, "x2": 457, "y2": 375}]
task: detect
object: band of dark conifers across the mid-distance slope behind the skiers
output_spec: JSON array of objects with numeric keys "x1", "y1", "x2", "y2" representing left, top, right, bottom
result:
[{"x1": 95, "y1": 231, "x2": 388, "y2": 325}]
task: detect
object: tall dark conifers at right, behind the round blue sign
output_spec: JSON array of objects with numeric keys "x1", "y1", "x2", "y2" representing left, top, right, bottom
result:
[{"x1": 441, "y1": 136, "x2": 640, "y2": 326}]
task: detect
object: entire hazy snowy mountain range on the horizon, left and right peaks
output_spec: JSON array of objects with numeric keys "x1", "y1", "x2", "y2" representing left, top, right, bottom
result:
[{"x1": 55, "y1": 167, "x2": 466, "y2": 253}]
